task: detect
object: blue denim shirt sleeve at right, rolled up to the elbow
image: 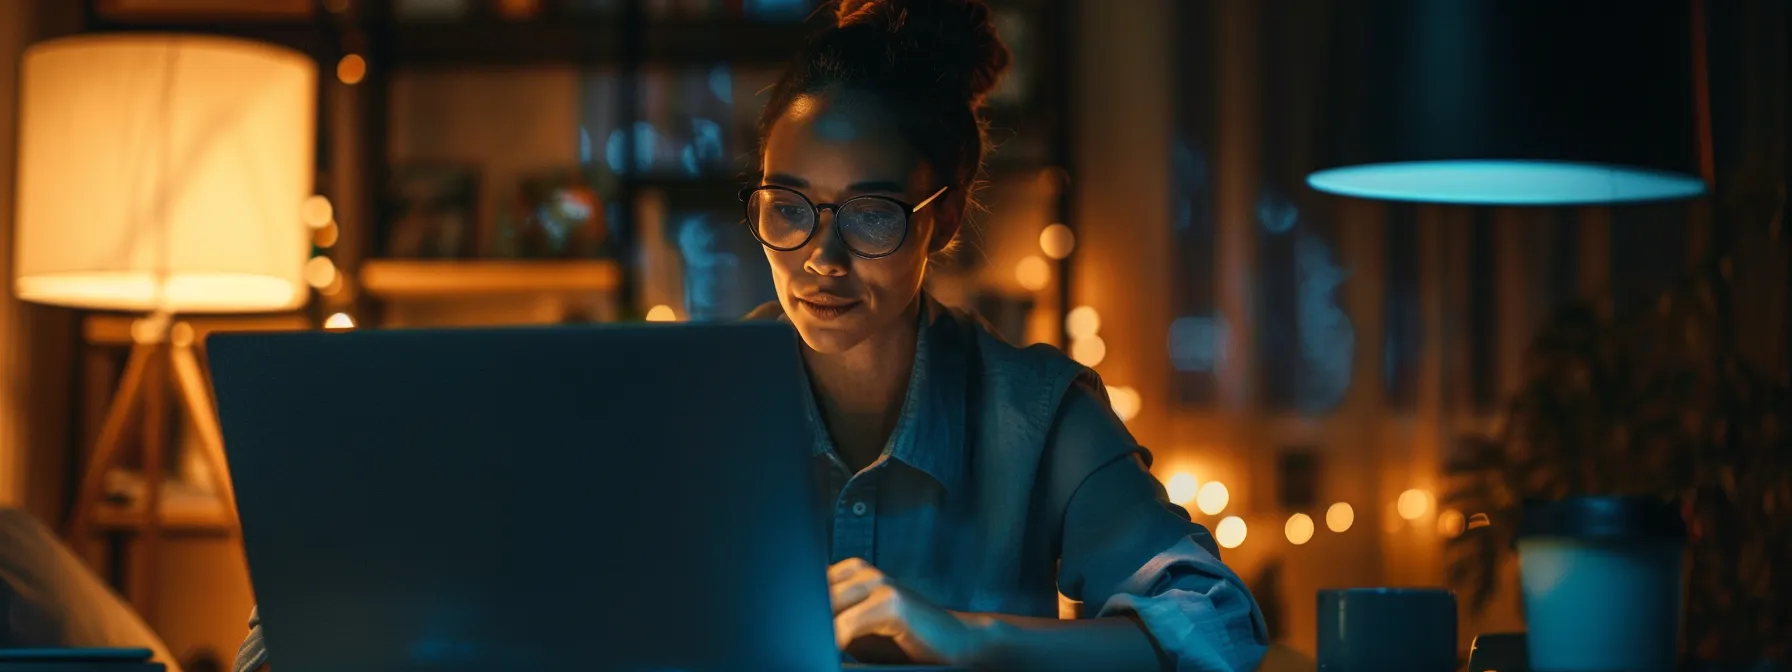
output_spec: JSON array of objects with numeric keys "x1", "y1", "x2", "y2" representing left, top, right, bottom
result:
[{"x1": 1054, "y1": 387, "x2": 1269, "y2": 672}]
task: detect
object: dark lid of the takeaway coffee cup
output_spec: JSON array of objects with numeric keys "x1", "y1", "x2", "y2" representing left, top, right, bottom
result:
[{"x1": 1518, "y1": 495, "x2": 1686, "y2": 541}]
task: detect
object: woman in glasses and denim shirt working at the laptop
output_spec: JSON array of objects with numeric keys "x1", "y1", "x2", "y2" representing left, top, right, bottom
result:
[{"x1": 238, "y1": 0, "x2": 1269, "y2": 670}]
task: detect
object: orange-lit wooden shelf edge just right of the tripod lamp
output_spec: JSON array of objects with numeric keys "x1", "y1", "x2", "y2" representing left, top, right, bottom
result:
[{"x1": 360, "y1": 260, "x2": 622, "y2": 299}]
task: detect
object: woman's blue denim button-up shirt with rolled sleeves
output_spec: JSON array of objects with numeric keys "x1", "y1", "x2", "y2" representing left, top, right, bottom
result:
[{"x1": 235, "y1": 296, "x2": 1269, "y2": 672}]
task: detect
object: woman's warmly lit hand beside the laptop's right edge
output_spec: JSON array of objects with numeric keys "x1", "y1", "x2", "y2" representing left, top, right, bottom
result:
[{"x1": 828, "y1": 557, "x2": 978, "y2": 665}]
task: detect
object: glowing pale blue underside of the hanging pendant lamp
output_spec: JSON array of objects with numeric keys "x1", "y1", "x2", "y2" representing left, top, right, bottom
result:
[{"x1": 1306, "y1": 159, "x2": 1704, "y2": 206}]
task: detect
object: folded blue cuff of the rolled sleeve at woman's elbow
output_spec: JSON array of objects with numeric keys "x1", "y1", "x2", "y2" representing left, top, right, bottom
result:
[{"x1": 1098, "y1": 538, "x2": 1269, "y2": 672}]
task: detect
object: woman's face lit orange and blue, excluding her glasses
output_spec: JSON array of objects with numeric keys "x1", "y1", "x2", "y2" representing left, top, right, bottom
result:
[{"x1": 763, "y1": 91, "x2": 950, "y2": 353}]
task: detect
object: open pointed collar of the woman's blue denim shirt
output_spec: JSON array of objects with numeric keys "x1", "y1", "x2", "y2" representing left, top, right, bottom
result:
[{"x1": 785, "y1": 292, "x2": 968, "y2": 491}]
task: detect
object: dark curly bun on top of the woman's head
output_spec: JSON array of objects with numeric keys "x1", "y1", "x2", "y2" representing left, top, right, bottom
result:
[{"x1": 833, "y1": 0, "x2": 1009, "y2": 106}]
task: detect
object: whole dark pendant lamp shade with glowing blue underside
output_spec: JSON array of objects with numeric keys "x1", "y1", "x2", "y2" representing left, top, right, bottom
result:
[{"x1": 1308, "y1": 0, "x2": 1706, "y2": 206}]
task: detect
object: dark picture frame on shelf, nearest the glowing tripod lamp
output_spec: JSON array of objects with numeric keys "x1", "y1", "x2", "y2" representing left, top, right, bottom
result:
[{"x1": 378, "y1": 163, "x2": 480, "y2": 258}]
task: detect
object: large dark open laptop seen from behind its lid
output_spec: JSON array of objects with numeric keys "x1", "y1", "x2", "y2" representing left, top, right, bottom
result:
[{"x1": 206, "y1": 323, "x2": 960, "y2": 672}]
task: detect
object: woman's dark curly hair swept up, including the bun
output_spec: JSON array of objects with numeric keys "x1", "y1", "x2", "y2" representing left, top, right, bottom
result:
[{"x1": 760, "y1": 0, "x2": 1009, "y2": 244}]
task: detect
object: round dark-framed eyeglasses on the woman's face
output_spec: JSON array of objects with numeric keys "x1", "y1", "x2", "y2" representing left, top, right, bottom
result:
[{"x1": 740, "y1": 185, "x2": 948, "y2": 260}]
